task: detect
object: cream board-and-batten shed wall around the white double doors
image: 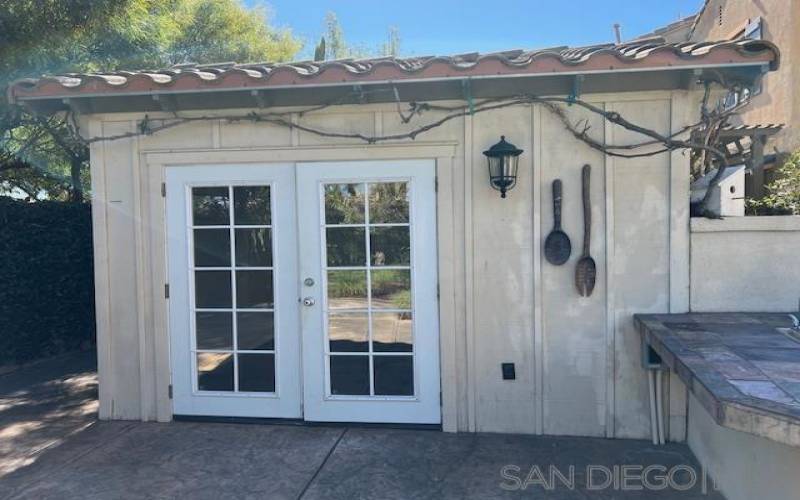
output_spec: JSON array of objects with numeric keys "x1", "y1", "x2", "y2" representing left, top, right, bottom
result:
[{"x1": 88, "y1": 91, "x2": 697, "y2": 438}]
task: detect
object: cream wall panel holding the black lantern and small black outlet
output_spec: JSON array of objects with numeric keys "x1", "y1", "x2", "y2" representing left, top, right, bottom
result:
[{"x1": 470, "y1": 106, "x2": 535, "y2": 433}]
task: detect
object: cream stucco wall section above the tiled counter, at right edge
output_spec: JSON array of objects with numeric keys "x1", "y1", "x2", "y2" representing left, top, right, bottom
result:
[{"x1": 691, "y1": 216, "x2": 800, "y2": 312}]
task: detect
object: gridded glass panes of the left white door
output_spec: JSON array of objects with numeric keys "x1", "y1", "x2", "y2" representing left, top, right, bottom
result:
[{"x1": 190, "y1": 185, "x2": 275, "y2": 393}]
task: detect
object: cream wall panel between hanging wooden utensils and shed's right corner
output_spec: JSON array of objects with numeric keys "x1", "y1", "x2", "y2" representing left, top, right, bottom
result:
[{"x1": 609, "y1": 101, "x2": 671, "y2": 438}]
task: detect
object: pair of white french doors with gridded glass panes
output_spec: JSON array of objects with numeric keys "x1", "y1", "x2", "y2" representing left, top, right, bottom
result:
[{"x1": 166, "y1": 161, "x2": 440, "y2": 423}]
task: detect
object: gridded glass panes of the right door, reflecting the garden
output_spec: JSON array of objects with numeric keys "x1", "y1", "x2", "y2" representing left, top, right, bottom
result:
[{"x1": 322, "y1": 181, "x2": 414, "y2": 396}]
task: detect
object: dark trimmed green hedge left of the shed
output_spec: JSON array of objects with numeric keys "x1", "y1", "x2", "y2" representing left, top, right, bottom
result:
[{"x1": 0, "y1": 197, "x2": 95, "y2": 364}]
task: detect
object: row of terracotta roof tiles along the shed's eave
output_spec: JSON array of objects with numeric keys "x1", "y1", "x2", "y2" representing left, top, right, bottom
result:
[{"x1": 9, "y1": 39, "x2": 780, "y2": 100}]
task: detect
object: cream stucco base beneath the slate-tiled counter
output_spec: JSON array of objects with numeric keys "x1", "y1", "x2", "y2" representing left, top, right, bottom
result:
[{"x1": 687, "y1": 395, "x2": 800, "y2": 500}]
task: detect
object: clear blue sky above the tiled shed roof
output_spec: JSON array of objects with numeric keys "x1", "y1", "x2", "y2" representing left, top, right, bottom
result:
[{"x1": 253, "y1": 0, "x2": 703, "y2": 56}]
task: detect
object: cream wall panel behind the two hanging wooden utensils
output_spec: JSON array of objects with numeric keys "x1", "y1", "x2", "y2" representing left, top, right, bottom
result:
[{"x1": 540, "y1": 103, "x2": 606, "y2": 436}]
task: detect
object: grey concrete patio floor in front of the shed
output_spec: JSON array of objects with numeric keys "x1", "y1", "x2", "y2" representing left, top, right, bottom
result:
[{"x1": 0, "y1": 352, "x2": 722, "y2": 499}]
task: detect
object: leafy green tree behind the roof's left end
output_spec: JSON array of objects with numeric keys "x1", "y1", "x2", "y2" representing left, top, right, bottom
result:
[{"x1": 0, "y1": 0, "x2": 302, "y2": 201}]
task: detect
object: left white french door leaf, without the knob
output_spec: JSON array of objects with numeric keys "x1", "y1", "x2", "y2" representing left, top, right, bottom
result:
[{"x1": 166, "y1": 165, "x2": 302, "y2": 418}]
